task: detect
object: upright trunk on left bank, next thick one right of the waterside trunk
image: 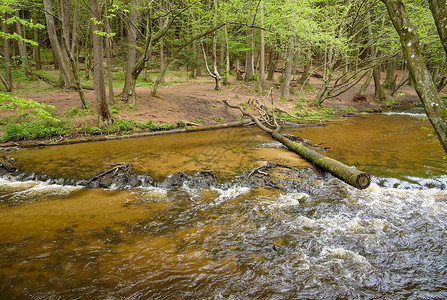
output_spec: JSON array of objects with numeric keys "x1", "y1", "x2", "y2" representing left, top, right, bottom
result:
[{"x1": 123, "y1": 0, "x2": 137, "y2": 101}]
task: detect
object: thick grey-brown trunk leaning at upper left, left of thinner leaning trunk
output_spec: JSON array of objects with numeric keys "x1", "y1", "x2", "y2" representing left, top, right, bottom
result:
[{"x1": 43, "y1": 0, "x2": 73, "y2": 88}]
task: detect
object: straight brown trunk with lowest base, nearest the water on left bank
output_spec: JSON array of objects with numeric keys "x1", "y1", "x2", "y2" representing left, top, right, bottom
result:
[{"x1": 90, "y1": 0, "x2": 113, "y2": 127}]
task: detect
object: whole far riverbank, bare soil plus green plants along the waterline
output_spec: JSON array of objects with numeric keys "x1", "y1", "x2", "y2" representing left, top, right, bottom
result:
[{"x1": 0, "y1": 70, "x2": 428, "y2": 147}]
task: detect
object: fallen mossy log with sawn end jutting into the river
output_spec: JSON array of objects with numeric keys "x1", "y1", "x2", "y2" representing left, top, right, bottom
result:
[{"x1": 224, "y1": 100, "x2": 371, "y2": 189}]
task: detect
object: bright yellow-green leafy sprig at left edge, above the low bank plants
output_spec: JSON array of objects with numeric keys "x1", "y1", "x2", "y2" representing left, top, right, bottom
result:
[{"x1": 0, "y1": 93, "x2": 59, "y2": 121}]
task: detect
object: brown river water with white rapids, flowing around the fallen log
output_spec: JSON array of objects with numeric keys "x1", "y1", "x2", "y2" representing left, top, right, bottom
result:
[{"x1": 0, "y1": 114, "x2": 447, "y2": 299}]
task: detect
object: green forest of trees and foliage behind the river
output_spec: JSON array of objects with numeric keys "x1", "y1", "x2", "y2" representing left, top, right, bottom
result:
[{"x1": 0, "y1": 0, "x2": 447, "y2": 149}]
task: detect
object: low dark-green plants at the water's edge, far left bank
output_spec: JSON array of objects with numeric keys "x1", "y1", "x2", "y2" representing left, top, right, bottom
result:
[{"x1": 1, "y1": 120, "x2": 70, "y2": 142}]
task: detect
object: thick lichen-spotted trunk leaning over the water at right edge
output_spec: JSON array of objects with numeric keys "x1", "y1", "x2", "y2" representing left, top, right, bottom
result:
[{"x1": 381, "y1": 0, "x2": 447, "y2": 152}]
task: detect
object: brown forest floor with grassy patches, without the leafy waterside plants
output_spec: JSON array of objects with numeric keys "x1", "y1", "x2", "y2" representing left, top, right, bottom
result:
[{"x1": 0, "y1": 67, "x2": 434, "y2": 144}]
